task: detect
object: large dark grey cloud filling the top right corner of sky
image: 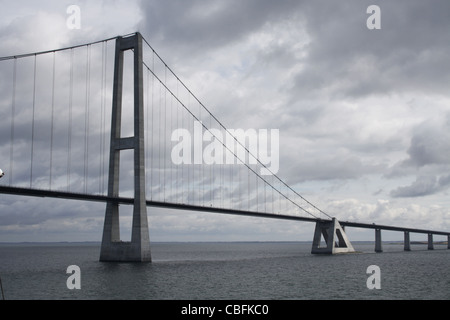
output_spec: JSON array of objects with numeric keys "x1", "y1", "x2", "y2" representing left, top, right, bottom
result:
[{"x1": 294, "y1": 1, "x2": 450, "y2": 98}]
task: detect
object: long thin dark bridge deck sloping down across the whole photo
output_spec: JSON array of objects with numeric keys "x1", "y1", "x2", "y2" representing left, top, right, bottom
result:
[{"x1": 0, "y1": 186, "x2": 450, "y2": 236}]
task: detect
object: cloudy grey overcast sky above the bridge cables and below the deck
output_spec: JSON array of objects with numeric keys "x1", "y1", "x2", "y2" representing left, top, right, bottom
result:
[{"x1": 0, "y1": 0, "x2": 450, "y2": 241}]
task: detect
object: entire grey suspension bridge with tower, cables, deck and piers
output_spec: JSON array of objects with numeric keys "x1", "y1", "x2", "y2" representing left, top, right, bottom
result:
[{"x1": 0, "y1": 33, "x2": 450, "y2": 261}]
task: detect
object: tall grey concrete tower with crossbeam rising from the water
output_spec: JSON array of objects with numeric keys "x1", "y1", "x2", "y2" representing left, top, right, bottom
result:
[{"x1": 100, "y1": 33, "x2": 151, "y2": 262}]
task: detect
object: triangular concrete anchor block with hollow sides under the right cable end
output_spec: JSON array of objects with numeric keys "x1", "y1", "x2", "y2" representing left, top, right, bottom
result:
[{"x1": 311, "y1": 218, "x2": 355, "y2": 254}]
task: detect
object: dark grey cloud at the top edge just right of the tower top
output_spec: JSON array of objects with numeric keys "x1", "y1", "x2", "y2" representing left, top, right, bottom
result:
[{"x1": 140, "y1": 0, "x2": 302, "y2": 55}]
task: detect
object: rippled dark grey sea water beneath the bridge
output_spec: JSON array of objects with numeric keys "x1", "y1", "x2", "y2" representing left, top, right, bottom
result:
[{"x1": 0, "y1": 242, "x2": 450, "y2": 300}]
